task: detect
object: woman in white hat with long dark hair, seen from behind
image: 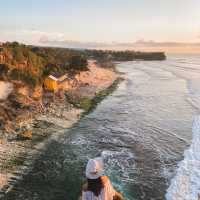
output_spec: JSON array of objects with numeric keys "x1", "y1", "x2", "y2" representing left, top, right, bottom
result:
[{"x1": 79, "y1": 158, "x2": 124, "y2": 200}]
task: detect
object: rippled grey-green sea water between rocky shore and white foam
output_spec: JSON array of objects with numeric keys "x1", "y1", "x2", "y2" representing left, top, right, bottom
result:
[{"x1": 2, "y1": 56, "x2": 200, "y2": 200}]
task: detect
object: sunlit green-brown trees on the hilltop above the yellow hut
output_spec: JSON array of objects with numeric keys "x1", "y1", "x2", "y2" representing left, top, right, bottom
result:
[{"x1": 1, "y1": 42, "x2": 87, "y2": 87}]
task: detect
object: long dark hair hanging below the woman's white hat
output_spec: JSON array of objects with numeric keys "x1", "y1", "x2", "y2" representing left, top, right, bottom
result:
[{"x1": 87, "y1": 177, "x2": 104, "y2": 197}]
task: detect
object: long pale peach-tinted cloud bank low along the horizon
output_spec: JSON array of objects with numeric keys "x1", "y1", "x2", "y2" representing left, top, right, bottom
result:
[{"x1": 1, "y1": 29, "x2": 200, "y2": 52}]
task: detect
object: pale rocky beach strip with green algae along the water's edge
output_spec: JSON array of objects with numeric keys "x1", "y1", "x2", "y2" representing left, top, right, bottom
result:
[{"x1": 0, "y1": 62, "x2": 122, "y2": 194}]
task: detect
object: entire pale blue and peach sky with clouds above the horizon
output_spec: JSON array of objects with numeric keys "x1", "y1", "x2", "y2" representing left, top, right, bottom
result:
[{"x1": 0, "y1": 0, "x2": 200, "y2": 52}]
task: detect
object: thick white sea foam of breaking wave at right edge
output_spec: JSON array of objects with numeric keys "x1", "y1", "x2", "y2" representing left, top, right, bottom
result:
[{"x1": 166, "y1": 116, "x2": 200, "y2": 200}]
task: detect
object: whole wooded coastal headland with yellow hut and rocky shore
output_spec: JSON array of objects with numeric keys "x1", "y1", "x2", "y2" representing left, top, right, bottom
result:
[{"x1": 0, "y1": 42, "x2": 166, "y2": 194}]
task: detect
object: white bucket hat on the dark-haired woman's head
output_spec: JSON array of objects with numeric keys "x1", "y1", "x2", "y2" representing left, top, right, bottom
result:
[{"x1": 85, "y1": 157, "x2": 103, "y2": 179}]
